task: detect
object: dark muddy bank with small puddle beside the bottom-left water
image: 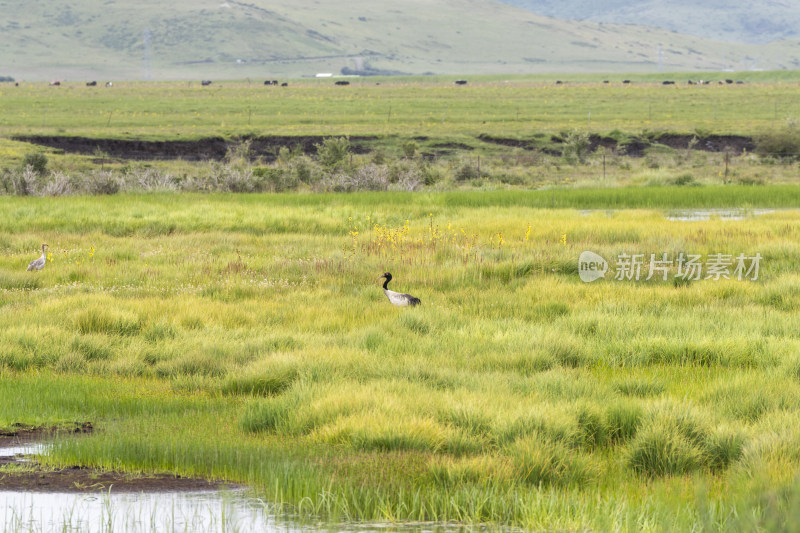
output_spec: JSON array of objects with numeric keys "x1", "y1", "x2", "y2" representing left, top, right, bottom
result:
[{"x1": 0, "y1": 422, "x2": 240, "y2": 492}]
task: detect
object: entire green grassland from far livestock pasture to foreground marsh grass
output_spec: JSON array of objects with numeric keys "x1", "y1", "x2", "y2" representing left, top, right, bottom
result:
[{"x1": 0, "y1": 73, "x2": 800, "y2": 531}]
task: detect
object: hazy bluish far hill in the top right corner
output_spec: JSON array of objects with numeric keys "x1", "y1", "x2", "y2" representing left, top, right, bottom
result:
[{"x1": 502, "y1": 0, "x2": 800, "y2": 44}]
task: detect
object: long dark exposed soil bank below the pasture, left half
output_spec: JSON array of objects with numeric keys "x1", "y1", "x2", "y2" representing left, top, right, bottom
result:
[{"x1": 14, "y1": 135, "x2": 377, "y2": 161}]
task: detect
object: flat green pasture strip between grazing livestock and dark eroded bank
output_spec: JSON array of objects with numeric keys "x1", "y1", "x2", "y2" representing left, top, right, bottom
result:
[{"x1": 0, "y1": 73, "x2": 799, "y2": 139}]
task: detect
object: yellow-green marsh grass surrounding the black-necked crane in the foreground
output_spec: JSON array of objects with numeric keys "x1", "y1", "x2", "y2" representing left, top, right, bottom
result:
[{"x1": 0, "y1": 191, "x2": 800, "y2": 531}]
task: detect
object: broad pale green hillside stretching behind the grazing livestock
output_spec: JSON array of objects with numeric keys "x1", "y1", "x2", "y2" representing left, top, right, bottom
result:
[{"x1": 0, "y1": 0, "x2": 800, "y2": 81}]
